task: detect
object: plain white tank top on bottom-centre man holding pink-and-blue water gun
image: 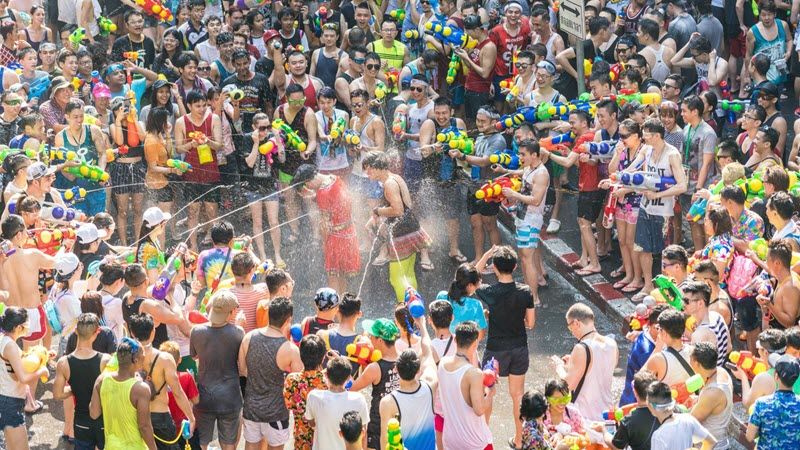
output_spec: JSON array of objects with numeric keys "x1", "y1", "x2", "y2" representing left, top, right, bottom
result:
[{"x1": 438, "y1": 364, "x2": 494, "y2": 450}]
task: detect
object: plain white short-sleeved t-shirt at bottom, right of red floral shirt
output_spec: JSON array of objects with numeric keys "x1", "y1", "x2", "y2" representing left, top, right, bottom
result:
[{"x1": 305, "y1": 389, "x2": 369, "y2": 450}]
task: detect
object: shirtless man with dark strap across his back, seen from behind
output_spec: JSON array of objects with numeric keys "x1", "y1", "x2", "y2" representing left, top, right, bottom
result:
[{"x1": 128, "y1": 314, "x2": 195, "y2": 450}]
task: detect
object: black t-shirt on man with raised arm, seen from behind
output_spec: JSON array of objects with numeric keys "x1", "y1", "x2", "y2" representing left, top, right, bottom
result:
[{"x1": 475, "y1": 282, "x2": 533, "y2": 351}]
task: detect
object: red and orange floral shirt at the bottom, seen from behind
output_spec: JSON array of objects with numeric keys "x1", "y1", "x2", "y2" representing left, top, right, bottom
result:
[{"x1": 283, "y1": 370, "x2": 328, "y2": 450}]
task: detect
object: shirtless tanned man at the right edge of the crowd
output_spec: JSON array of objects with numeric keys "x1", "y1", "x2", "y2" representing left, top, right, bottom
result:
[{"x1": 756, "y1": 239, "x2": 800, "y2": 329}]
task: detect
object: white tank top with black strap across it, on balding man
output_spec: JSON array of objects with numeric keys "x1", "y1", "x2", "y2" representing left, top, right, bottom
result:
[{"x1": 574, "y1": 336, "x2": 617, "y2": 420}]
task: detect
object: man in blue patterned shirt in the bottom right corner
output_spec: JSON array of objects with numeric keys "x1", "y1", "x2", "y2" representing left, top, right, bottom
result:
[{"x1": 746, "y1": 355, "x2": 800, "y2": 450}]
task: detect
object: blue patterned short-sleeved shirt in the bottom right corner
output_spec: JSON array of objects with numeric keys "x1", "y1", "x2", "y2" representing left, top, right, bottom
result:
[{"x1": 750, "y1": 391, "x2": 800, "y2": 450}]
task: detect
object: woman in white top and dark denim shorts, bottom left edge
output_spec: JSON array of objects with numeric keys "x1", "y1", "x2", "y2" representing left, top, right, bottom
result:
[{"x1": 0, "y1": 306, "x2": 48, "y2": 450}]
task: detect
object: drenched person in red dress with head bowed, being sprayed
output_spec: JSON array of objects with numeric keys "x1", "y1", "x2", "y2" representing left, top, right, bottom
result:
[{"x1": 293, "y1": 164, "x2": 361, "y2": 292}]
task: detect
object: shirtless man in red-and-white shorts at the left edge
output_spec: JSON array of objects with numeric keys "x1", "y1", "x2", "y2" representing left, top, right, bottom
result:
[{"x1": 0, "y1": 214, "x2": 56, "y2": 412}]
